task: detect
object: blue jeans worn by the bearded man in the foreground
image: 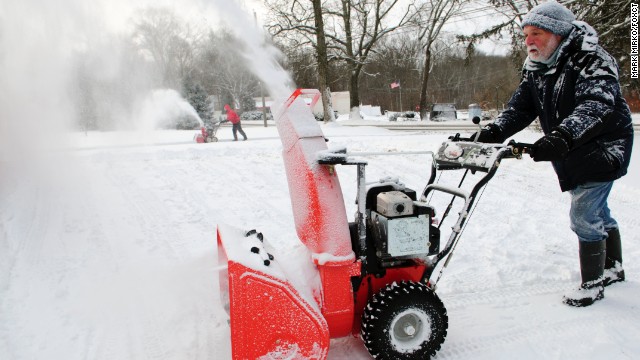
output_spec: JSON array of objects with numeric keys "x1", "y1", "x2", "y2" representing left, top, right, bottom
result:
[{"x1": 569, "y1": 181, "x2": 618, "y2": 241}]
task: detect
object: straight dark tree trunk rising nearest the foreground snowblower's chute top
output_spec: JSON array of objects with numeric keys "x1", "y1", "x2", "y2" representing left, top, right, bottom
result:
[{"x1": 311, "y1": 0, "x2": 335, "y2": 123}]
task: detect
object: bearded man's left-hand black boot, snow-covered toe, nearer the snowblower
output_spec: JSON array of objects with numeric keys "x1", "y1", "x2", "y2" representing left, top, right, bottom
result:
[{"x1": 562, "y1": 240, "x2": 607, "y2": 307}]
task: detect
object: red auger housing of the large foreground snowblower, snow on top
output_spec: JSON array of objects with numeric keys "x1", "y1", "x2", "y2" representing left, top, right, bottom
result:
[{"x1": 218, "y1": 225, "x2": 329, "y2": 359}]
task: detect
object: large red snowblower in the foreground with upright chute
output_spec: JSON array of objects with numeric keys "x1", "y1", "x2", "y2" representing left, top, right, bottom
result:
[{"x1": 217, "y1": 89, "x2": 530, "y2": 360}]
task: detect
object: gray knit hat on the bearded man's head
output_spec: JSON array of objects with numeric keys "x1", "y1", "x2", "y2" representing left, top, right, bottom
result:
[{"x1": 522, "y1": 1, "x2": 576, "y2": 37}]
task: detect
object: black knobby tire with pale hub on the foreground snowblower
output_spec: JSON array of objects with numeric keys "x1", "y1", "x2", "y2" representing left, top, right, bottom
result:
[{"x1": 360, "y1": 281, "x2": 449, "y2": 360}]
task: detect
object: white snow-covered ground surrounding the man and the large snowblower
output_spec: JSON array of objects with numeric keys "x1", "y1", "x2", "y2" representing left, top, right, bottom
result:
[{"x1": 0, "y1": 124, "x2": 640, "y2": 360}]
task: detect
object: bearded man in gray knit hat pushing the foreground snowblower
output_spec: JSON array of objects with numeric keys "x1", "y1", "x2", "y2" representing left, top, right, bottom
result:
[{"x1": 478, "y1": 2, "x2": 633, "y2": 306}]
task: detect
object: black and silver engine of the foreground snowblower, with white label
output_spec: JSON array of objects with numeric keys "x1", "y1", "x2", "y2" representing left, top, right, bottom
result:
[{"x1": 366, "y1": 186, "x2": 440, "y2": 268}]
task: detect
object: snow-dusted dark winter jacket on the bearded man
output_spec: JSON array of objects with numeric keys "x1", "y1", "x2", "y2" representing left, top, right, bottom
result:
[{"x1": 493, "y1": 21, "x2": 633, "y2": 191}]
